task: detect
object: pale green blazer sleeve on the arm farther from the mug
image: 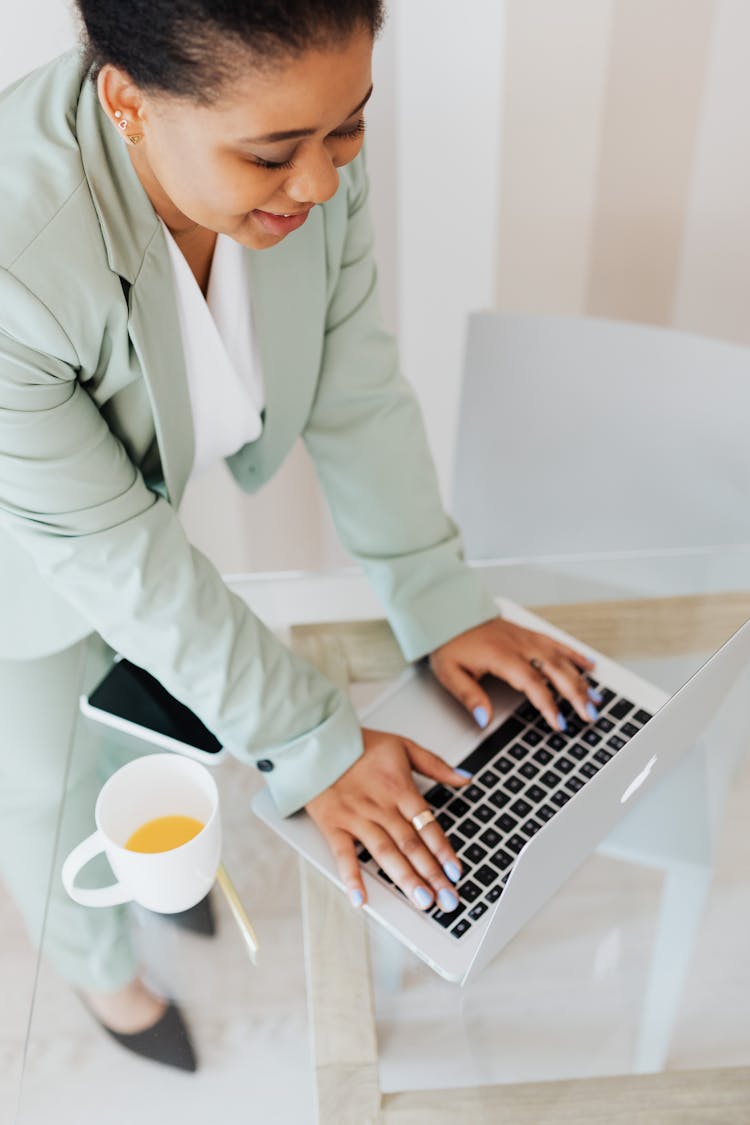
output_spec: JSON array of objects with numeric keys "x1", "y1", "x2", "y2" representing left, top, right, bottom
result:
[{"x1": 304, "y1": 159, "x2": 498, "y2": 660}]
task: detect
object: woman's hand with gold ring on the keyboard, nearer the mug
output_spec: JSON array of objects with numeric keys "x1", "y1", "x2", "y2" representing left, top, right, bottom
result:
[{"x1": 306, "y1": 729, "x2": 469, "y2": 912}]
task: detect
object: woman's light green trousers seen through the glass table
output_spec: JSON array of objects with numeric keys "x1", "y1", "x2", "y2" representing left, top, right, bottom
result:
[{"x1": 0, "y1": 633, "x2": 137, "y2": 991}]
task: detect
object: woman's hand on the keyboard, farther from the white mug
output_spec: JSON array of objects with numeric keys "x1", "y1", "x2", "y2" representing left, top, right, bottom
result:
[{"x1": 430, "y1": 618, "x2": 600, "y2": 730}]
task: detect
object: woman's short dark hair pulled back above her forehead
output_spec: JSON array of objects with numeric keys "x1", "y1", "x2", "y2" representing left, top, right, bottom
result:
[{"x1": 76, "y1": 0, "x2": 385, "y2": 104}]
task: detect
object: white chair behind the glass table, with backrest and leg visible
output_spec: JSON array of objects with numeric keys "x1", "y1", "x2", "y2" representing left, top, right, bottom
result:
[{"x1": 452, "y1": 313, "x2": 750, "y2": 1072}]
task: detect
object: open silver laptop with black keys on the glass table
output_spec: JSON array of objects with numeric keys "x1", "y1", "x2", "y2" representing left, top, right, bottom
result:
[{"x1": 253, "y1": 600, "x2": 750, "y2": 983}]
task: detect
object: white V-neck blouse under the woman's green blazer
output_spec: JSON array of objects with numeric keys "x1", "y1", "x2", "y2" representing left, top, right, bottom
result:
[{"x1": 162, "y1": 223, "x2": 265, "y2": 478}]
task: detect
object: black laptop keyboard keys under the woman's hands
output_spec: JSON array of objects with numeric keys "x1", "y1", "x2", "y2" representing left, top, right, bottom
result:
[{"x1": 359, "y1": 676, "x2": 652, "y2": 939}]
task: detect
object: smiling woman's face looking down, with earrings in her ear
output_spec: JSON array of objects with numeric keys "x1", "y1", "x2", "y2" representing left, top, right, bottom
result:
[{"x1": 99, "y1": 29, "x2": 372, "y2": 250}]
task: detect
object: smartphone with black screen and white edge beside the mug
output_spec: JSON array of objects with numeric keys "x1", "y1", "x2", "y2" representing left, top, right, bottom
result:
[{"x1": 79, "y1": 655, "x2": 226, "y2": 765}]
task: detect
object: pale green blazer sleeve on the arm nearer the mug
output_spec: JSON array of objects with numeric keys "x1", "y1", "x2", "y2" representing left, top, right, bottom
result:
[{"x1": 0, "y1": 270, "x2": 362, "y2": 815}]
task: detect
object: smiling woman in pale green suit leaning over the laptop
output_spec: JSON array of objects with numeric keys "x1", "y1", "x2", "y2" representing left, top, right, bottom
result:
[{"x1": 0, "y1": 0, "x2": 596, "y2": 1067}]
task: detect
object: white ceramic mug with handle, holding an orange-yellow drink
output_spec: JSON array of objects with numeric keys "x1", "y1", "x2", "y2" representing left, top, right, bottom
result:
[{"x1": 62, "y1": 754, "x2": 222, "y2": 914}]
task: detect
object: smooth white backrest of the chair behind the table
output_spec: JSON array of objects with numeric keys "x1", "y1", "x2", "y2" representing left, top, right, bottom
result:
[{"x1": 452, "y1": 313, "x2": 750, "y2": 559}]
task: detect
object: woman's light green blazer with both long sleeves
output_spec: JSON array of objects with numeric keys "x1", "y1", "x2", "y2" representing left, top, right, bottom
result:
[{"x1": 0, "y1": 52, "x2": 496, "y2": 813}]
